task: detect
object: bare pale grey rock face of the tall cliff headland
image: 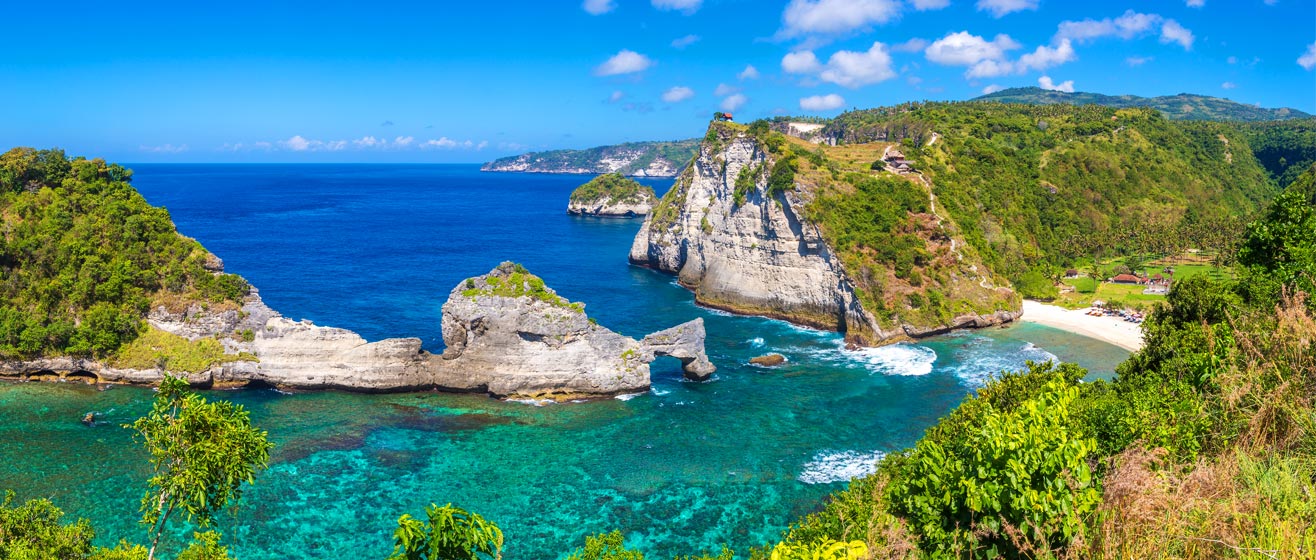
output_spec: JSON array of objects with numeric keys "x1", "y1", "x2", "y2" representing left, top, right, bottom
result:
[{"x1": 630, "y1": 135, "x2": 876, "y2": 341}]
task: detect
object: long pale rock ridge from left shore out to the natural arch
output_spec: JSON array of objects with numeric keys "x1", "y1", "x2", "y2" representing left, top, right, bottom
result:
[{"x1": 0, "y1": 263, "x2": 715, "y2": 398}]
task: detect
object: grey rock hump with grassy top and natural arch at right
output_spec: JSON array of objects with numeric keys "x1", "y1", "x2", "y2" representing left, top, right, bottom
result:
[{"x1": 436, "y1": 263, "x2": 713, "y2": 398}]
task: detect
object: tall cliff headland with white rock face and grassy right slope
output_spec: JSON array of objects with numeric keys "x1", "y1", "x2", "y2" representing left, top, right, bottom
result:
[{"x1": 629, "y1": 122, "x2": 1020, "y2": 346}]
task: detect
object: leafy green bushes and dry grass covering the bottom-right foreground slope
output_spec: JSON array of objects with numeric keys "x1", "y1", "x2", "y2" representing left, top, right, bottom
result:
[{"x1": 768, "y1": 164, "x2": 1316, "y2": 559}]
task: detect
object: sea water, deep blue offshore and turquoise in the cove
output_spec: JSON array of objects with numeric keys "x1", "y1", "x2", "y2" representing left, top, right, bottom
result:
[{"x1": 0, "y1": 164, "x2": 1128, "y2": 560}]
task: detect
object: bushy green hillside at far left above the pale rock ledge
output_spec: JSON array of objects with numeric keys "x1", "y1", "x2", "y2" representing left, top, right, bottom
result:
[{"x1": 0, "y1": 147, "x2": 247, "y2": 359}]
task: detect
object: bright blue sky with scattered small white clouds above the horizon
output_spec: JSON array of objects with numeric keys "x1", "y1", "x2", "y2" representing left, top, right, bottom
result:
[{"x1": 0, "y1": 0, "x2": 1316, "y2": 162}]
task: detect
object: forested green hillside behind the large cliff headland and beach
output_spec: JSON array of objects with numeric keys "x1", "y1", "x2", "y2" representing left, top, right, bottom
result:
[{"x1": 825, "y1": 103, "x2": 1278, "y2": 297}]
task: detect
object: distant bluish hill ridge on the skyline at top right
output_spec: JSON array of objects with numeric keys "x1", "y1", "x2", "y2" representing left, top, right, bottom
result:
[{"x1": 973, "y1": 88, "x2": 1312, "y2": 121}]
